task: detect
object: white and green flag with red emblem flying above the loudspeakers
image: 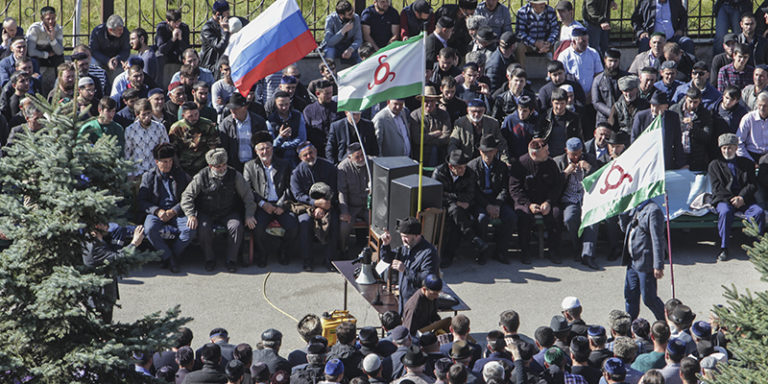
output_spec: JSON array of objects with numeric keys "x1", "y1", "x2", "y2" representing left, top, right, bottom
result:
[{"x1": 338, "y1": 32, "x2": 424, "y2": 111}]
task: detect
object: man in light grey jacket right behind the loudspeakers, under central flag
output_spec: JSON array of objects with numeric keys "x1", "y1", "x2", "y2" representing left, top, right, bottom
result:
[{"x1": 373, "y1": 99, "x2": 412, "y2": 156}]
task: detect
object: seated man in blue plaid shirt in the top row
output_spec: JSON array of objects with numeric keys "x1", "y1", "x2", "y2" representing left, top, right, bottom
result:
[{"x1": 515, "y1": 0, "x2": 560, "y2": 68}]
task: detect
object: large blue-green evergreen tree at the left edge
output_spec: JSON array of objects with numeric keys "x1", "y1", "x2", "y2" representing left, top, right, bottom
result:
[{"x1": 0, "y1": 96, "x2": 189, "y2": 383}]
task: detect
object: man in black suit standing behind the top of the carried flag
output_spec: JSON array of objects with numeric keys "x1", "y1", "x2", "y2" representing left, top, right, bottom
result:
[{"x1": 631, "y1": 92, "x2": 687, "y2": 170}]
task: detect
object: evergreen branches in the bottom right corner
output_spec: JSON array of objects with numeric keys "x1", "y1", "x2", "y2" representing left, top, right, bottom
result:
[{"x1": 710, "y1": 223, "x2": 768, "y2": 384}]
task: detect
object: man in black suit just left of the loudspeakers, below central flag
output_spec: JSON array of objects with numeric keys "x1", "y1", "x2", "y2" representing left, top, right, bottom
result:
[{"x1": 325, "y1": 111, "x2": 379, "y2": 164}]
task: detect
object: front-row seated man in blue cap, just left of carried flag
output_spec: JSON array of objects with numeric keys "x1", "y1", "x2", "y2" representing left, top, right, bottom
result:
[{"x1": 554, "y1": 137, "x2": 598, "y2": 269}]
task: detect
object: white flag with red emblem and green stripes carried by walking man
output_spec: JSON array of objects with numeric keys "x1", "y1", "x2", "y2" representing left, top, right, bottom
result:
[{"x1": 579, "y1": 115, "x2": 666, "y2": 234}]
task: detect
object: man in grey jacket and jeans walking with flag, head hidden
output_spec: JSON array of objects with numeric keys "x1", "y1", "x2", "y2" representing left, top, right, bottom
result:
[{"x1": 619, "y1": 200, "x2": 666, "y2": 320}]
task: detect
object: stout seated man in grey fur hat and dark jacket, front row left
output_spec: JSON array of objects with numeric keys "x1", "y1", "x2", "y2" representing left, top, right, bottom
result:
[{"x1": 181, "y1": 148, "x2": 256, "y2": 272}]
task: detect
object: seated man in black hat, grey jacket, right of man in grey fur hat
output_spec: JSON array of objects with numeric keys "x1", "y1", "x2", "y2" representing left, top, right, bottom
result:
[{"x1": 241, "y1": 130, "x2": 299, "y2": 267}]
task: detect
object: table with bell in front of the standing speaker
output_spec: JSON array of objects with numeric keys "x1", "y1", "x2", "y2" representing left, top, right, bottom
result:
[{"x1": 332, "y1": 260, "x2": 470, "y2": 316}]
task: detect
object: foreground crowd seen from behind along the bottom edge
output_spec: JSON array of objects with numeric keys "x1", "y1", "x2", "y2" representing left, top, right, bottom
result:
[{"x1": 133, "y1": 296, "x2": 732, "y2": 384}]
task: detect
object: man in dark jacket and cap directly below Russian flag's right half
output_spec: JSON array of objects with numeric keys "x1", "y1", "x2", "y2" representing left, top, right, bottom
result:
[{"x1": 267, "y1": 91, "x2": 307, "y2": 166}]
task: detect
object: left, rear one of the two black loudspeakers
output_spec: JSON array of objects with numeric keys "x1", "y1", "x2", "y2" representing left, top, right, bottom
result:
[{"x1": 371, "y1": 156, "x2": 419, "y2": 231}]
